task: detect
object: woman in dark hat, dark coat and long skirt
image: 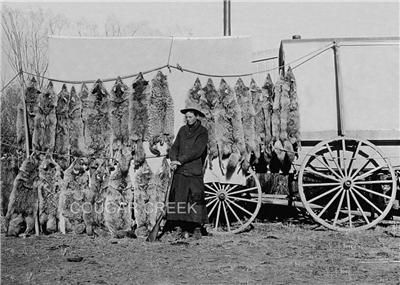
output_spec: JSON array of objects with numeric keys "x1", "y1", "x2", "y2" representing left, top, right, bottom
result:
[{"x1": 167, "y1": 108, "x2": 208, "y2": 238}]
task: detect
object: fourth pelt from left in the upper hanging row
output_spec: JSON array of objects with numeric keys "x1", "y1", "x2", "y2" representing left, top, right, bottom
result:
[{"x1": 68, "y1": 84, "x2": 89, "y2": 156}]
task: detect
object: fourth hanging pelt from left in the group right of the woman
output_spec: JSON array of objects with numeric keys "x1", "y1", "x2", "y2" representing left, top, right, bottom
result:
[{"x1": 234, "y1": 78, "x2": 259, "y2": 170}]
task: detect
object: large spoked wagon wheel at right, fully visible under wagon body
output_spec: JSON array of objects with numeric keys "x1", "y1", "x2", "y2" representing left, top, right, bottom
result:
[{"x1": 298, "y1": 137, "x2": 396, "y2": 231}]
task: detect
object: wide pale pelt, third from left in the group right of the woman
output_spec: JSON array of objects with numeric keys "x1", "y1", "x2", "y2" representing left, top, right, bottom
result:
[{"x1": 215, "y1": 79, "x2": 245, "y2": 176}]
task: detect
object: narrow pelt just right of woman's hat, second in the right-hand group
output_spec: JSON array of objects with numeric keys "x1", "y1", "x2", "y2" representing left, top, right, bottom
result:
[{"x1": 200, "y1": 78, "x2": 218, "y2": 166}]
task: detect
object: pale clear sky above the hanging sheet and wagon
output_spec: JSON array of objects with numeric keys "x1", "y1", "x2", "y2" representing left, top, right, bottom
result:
[{"x1": 2, "y1": 0, "x2": 400, "y2": 82}]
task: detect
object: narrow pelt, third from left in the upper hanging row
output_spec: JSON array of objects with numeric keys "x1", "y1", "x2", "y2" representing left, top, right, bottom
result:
[{"x1": 54, "y1": 84, "x2": 70, "y2": 170}]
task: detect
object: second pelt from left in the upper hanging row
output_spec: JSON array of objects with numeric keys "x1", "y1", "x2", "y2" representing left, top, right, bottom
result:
[{"x1": 32, "y1": 81, "x2": 57, "y2": 153}]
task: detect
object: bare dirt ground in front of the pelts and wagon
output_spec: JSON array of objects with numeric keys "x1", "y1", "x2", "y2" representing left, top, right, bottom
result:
[{"x1": 1, "y1": 216, "x2": 400, "y2": 284}]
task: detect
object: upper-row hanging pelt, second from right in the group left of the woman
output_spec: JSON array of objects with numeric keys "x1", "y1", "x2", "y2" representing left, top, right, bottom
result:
[{"x1": 129, "y1": 73, "x2": 150, "y2": 169}]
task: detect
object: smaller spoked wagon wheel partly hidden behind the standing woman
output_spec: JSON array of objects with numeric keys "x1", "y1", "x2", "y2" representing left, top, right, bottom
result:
[{"x1": 205, "y1": 171, "x2": 262, "y2": 233}]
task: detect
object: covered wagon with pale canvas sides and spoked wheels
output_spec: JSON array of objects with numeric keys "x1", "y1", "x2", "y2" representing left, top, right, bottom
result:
[{"x1": 205, "y1": 37, "x2": 400, "y2": 233}]
